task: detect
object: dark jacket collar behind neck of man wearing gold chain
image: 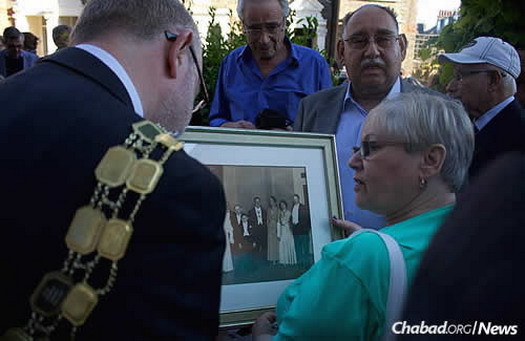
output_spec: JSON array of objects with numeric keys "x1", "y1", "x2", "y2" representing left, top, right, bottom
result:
[{"x1": 40, "y1": 47, "x2": 133, "y2": 108}]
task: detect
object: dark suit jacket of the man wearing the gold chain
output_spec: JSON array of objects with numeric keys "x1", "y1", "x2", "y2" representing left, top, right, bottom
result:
[{"x1": 0, "y1": 48, "x2": 226, "y2": 340}]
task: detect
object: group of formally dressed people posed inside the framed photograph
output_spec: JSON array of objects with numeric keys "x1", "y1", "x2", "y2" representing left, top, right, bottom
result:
[{"x1": 223, "y1": 194, "x2": 313, "y2": 272}]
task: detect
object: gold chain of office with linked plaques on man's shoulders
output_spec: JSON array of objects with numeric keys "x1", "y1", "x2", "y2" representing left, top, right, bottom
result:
[{"x1": 0, "y1": 121, "x2": 183, "y2": 341}]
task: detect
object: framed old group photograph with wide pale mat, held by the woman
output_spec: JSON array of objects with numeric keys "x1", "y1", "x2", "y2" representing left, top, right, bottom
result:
[{"x1": 180, "y1": 127, "x2": 343, "y2": 328}]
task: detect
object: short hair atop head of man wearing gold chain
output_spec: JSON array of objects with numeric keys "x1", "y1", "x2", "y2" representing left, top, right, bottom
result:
[{"x1": 71, "y1": 0, "x2": 200, "y2": 46}]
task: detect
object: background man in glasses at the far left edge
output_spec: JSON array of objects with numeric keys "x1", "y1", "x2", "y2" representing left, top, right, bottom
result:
[{"x1": 0, "y1": 26, "x2": 38, "y2": 78}]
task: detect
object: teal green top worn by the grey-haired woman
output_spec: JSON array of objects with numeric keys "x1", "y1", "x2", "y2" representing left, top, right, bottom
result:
[{"x1": 273, "y1": 206, "x2": 453, "y2": 340}]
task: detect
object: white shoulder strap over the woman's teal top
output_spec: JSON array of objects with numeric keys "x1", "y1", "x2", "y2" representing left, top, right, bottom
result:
[{"x1": 352, "y1": 229, "x2": 407, "y2": 340}]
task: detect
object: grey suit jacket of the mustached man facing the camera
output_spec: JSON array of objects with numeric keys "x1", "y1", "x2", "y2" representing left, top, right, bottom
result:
[{"x1": 294, "y1": 80, "x2": 443, "y2": 134}]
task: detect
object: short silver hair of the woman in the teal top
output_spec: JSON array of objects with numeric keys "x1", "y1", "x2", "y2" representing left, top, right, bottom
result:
[{"x1": 365, "y1": 91, "x2": 474, "y2": 192}]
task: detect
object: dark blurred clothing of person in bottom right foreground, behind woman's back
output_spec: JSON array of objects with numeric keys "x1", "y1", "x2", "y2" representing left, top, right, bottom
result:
[{"x1": 399, "y1": 152, "x2": 525, "y2": 340}]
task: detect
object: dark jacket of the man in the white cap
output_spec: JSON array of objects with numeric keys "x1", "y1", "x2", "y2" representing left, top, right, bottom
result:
[{"x1": 469, "y1": 100, "x2": 525, "y2": 179}]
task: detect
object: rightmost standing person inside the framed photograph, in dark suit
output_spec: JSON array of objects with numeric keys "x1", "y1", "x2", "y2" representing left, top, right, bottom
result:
[{"x1": 291, "y1": 194, "x2": 313, "y2": 266}]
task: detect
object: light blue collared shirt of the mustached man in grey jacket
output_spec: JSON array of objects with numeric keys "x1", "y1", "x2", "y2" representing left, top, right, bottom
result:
[{"x1": 335, "y1": 78, "x2": 401, "y2": 230}]
